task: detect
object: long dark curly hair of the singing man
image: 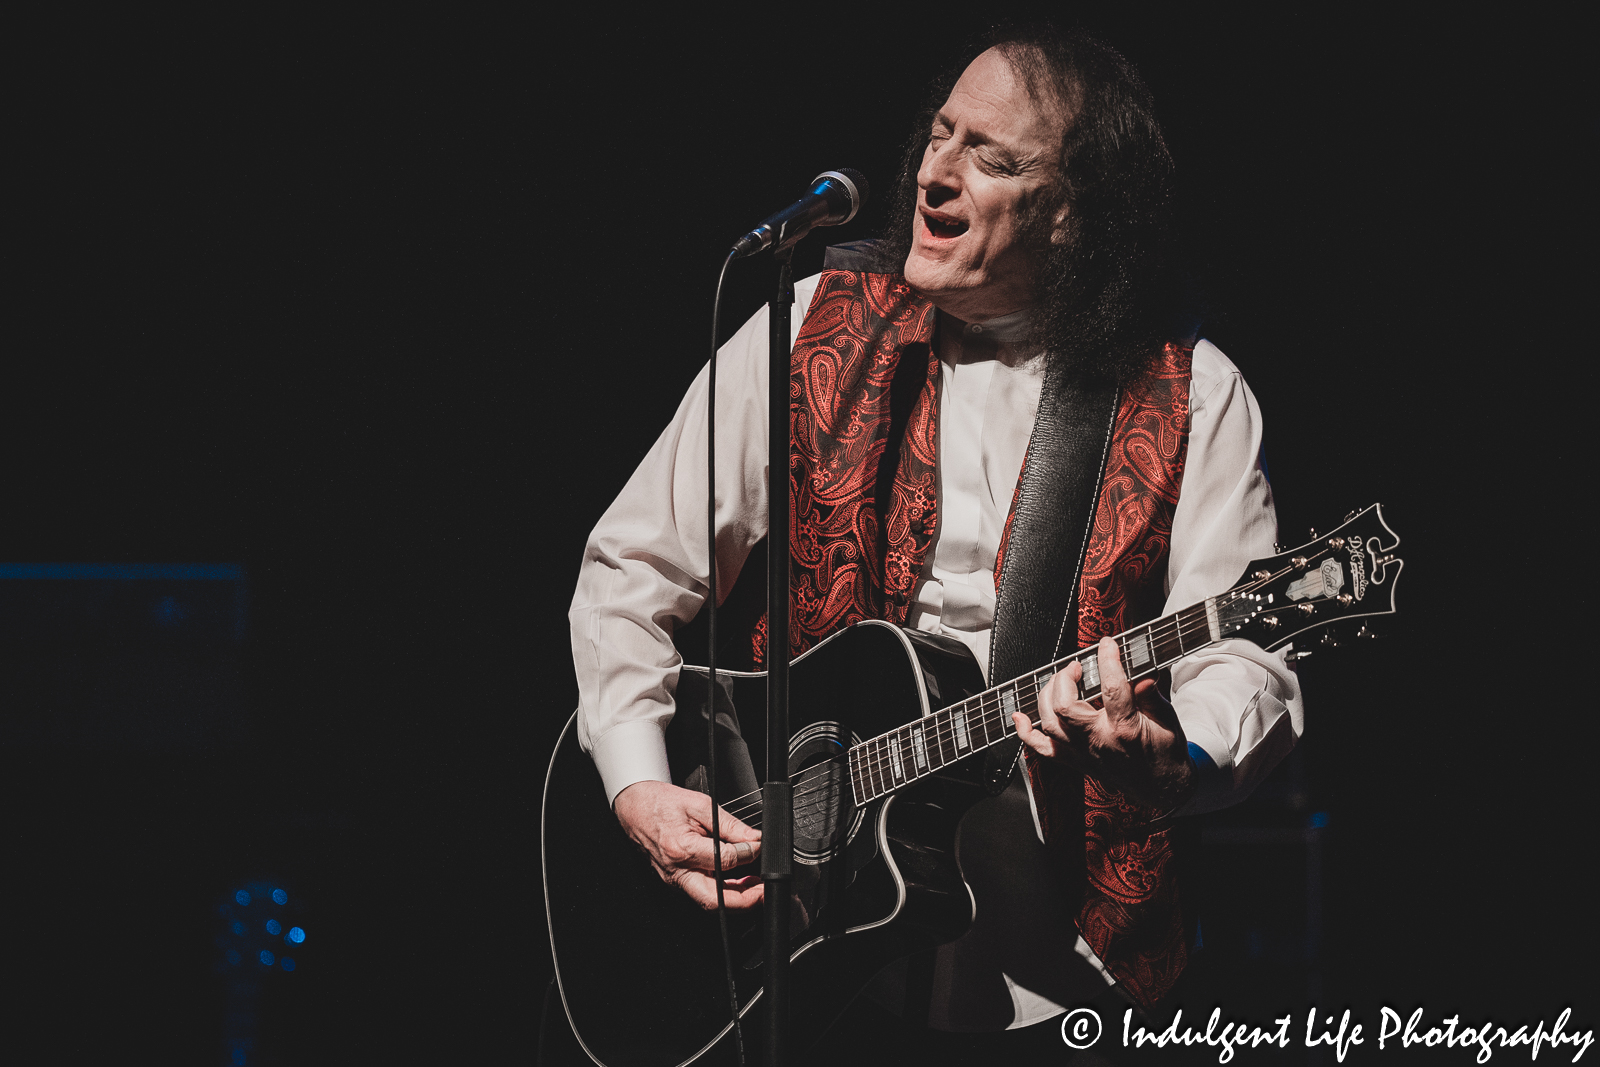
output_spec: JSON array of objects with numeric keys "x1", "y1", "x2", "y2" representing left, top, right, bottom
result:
[{"x1": 875, "y1": 26, "x2": 1195, "y2": 382}]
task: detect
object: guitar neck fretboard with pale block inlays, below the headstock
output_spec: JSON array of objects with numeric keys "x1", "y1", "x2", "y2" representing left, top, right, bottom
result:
[{"x1": 850, "y1": 597, "x2": 1224, "y2": 805}]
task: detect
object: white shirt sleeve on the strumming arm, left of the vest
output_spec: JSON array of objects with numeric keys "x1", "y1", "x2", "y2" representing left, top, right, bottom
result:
[{"x1": 568, "y1": 277, "x2": 816, "y2": 801}]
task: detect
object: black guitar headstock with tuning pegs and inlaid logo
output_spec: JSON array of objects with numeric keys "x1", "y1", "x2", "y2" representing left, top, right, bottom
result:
[{"x1": 1216, "y1": 504, "x2": 1405, "y2": 649}]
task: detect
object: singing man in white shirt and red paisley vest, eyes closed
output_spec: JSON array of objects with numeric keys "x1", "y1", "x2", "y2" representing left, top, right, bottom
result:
[{"x1": 571, "y1": 24, "x2": 1301, "y2": 1030}]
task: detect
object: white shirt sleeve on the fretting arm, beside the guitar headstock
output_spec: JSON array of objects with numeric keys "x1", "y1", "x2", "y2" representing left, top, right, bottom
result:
[{"x1": 1165, "y1": 341, "x2": 1304, "y2": 814}]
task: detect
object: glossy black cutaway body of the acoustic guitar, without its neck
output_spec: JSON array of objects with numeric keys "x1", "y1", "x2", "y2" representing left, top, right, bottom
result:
[{"x1": 542, "y1": 622, "x2": 986, "y2": 1067}]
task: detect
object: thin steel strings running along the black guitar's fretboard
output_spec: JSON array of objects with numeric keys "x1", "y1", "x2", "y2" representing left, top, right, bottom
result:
[{"x1": 710, "y1": 559, "x2": 1330, "y2": 822}]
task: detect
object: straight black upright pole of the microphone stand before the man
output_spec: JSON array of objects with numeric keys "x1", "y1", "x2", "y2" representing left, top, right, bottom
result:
[{"x1": 762, "y1": 240, "x2": 795, "y2": 1067}]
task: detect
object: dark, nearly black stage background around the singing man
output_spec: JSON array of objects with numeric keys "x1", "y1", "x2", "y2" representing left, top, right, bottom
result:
[{"x1": 0, "y1": 5, "x2": 1597, "y2": 1064}]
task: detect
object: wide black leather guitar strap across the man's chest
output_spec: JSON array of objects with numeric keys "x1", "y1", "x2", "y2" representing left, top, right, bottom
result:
[{"x1": 984, "y1": 363, "x2": 1118, "y2": 793}]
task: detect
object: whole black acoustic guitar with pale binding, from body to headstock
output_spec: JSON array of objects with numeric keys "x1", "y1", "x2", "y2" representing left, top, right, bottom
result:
[{"x1": 542, "y1": 504, "x2": 1402, "y2": 1067}]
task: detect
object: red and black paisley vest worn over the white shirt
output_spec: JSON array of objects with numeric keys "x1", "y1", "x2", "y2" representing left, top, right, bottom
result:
[{"x1": 754, "y1": 270, "x2": 1192, "y2": 1006}]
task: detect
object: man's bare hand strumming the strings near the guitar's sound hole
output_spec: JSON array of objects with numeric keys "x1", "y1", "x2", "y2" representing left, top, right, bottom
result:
[{"x1": 611, "y1": 782, "x2": 762, "y2": 909}]
